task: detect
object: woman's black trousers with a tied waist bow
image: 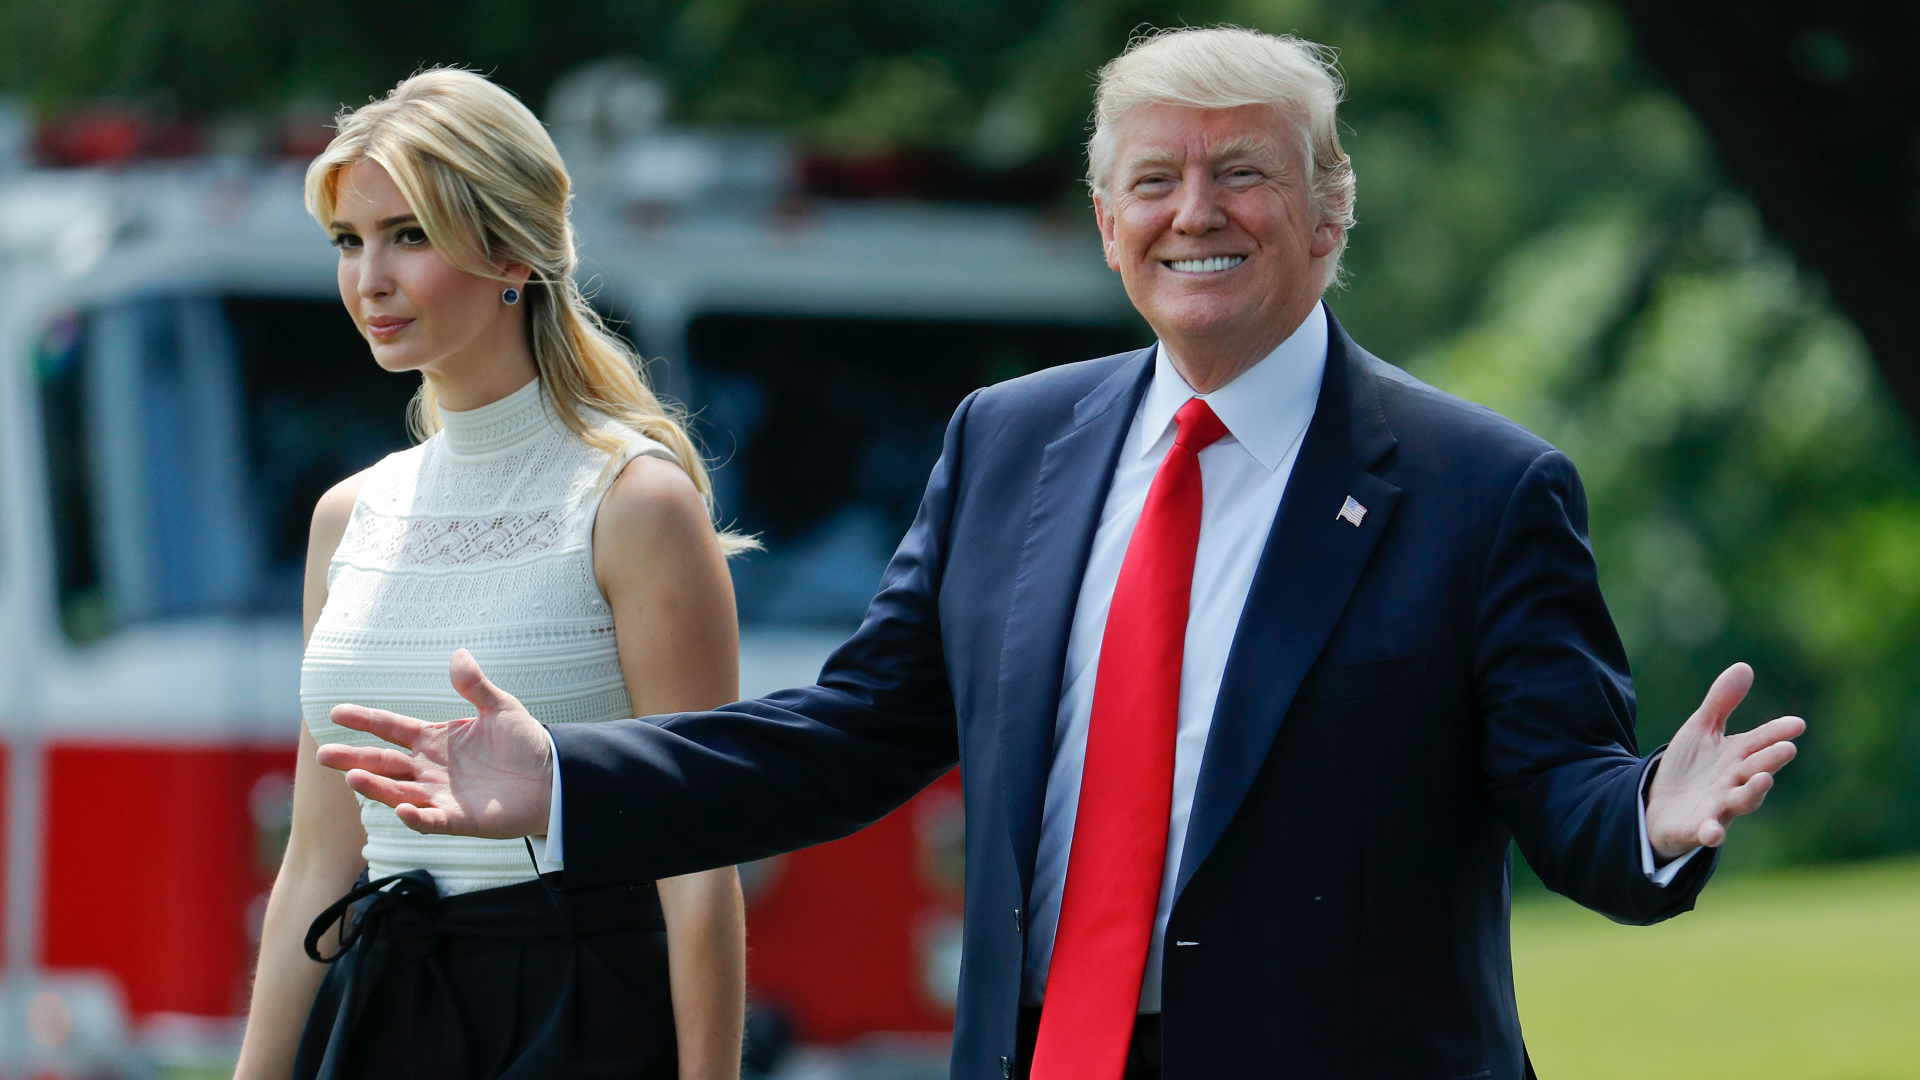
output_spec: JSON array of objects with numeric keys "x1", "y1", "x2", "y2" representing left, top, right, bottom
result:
[{"x1": 294, "y1": 871, "x2": 678, "y2": 1080}]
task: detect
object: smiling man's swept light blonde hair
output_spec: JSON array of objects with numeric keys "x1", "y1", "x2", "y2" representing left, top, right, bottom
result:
[{"x1": 1087, "y1": 27, "x2": 1354, "y2": 286}]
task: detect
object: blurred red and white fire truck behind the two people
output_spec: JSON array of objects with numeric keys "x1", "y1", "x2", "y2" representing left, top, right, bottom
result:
[{"x1": 0, "y1": 71, "x2": 1140, "y2": 1076}]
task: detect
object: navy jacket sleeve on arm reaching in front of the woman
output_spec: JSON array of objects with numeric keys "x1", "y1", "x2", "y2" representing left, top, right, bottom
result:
[{"x1": 551, "y1": 396, "x2": 973, "y2": 888}]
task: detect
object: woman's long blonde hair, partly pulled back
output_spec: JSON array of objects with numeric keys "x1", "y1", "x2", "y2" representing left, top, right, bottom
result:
[{"x1": 307, "y1": 67, "x2": 758, "y2": 555}]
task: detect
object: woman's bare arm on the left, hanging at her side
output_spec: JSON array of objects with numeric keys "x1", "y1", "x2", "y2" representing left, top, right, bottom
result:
[{"x1": 234, "y1": 475, "x2": 367, "y2": 1080}]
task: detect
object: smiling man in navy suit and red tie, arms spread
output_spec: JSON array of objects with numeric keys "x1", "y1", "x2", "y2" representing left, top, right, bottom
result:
[{"x1": 321, "y1": 29, "x2": 1805, "y2": 1080}]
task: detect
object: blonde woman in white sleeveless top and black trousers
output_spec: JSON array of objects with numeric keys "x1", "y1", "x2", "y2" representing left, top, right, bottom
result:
[{"x1": 238, "y1": 69, "x2": 749, "y2": 1080}]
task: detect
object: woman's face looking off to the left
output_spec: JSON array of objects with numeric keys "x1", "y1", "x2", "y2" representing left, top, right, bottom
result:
[{"x1": 328, "y1": 160, "x2": 526, "y2": 379}]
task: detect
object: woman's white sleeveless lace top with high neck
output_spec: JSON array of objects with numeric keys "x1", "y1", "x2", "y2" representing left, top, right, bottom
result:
[{"x1": 300, "y1": 380, "x2": 674, "y2": 896}]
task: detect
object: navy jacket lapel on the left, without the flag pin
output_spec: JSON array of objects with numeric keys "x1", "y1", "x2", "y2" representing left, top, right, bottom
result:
[{"x1": 998, "y1": 348, "x2": 1154, "y2": 896}]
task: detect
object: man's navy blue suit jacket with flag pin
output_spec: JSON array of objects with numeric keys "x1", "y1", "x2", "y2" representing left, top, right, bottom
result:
[{"x1": 553, "y1": 317, "x2": 1713, "y2": 1080}]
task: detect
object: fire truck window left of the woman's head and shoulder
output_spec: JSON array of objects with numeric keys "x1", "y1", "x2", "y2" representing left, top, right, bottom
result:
[{"x1": 35, "y1": 296, "x2": 413, "y2": 644}]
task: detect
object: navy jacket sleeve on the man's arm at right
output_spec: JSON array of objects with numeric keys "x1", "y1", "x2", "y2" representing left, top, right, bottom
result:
[{"x1": 1476, "y1": 452, "x2": 1718, "y2": 922}]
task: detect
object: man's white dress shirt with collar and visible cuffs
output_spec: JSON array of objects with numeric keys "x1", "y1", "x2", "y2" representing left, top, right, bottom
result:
[{"x1": 536, "y1": 295, "x2": 1692, "y2": 983}]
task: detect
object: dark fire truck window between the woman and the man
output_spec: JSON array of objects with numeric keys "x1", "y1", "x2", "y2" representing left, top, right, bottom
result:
[{"x1": 687, "y1": 315, "x2": 1150, "y2": 625}]
